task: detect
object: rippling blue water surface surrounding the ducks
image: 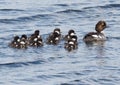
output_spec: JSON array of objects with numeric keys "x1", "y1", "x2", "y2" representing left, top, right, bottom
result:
[{"x1": 0, "y1": 0, "x2": 120, "y2": 85}]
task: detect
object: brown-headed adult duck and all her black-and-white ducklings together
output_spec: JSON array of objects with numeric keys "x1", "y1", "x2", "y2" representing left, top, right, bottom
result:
[{"x1": 9, "y1": 21, "x2": 106, "y2": 51}]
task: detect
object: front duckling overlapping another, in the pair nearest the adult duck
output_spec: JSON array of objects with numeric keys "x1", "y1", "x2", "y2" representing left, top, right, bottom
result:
[{"x1": 64, "y1": 35, "x2": 78, "y2": 51}]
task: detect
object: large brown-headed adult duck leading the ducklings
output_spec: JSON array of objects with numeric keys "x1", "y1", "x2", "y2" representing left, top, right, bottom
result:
[{"x1": 83, "y1": 20, "x2": 106, "y2": 42}]
